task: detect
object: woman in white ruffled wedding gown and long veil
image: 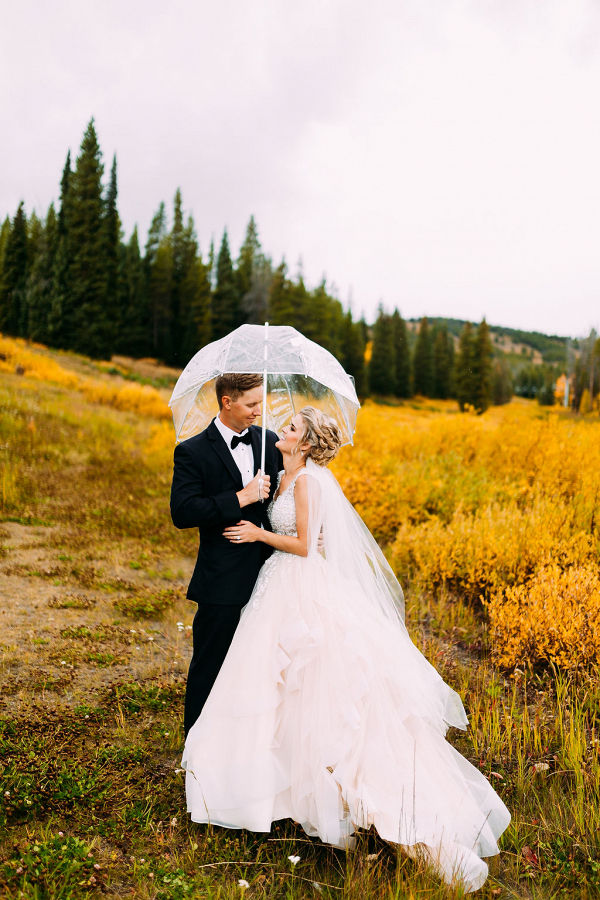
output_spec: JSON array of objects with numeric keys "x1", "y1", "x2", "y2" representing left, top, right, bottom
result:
[{"x1": 182, "y1": 406, "x2": 510, "y2": 891}]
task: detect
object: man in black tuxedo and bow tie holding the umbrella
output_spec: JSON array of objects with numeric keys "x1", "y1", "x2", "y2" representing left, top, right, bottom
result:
[{"x1": 171, "y1": 374, "x2": 283, "y2": 736}]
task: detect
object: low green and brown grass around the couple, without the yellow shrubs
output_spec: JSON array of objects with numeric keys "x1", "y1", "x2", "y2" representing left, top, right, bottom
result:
[{"x1": 0, "y1": 366, "x2": 600, "y2": 900}]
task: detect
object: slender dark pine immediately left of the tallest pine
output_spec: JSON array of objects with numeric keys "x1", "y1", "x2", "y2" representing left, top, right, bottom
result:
[{"x1": 48, "y1": 150, "x2": 73, "y2": 347}]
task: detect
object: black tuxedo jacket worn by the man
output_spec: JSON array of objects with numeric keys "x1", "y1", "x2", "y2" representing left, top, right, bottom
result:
[{"x1": 171, "y1": 420, "x2": 283, "y2": 607}]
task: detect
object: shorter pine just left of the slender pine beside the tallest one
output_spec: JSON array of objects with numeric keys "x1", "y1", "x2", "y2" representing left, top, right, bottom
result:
[{"x1": 27, "y1": 203, "x2": 58, "y2": 344}]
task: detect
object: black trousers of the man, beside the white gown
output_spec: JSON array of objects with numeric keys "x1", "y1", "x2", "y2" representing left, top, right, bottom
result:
[{"x1": 183, "y1": 603, "x2": 241, "y2": 737}]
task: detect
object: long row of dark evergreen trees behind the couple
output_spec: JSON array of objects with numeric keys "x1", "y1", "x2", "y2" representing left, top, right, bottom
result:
[{"x1": 0, "y1": 120, "x2": 548, "y2": 412}]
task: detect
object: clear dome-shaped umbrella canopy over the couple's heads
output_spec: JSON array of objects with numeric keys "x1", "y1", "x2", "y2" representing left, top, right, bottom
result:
[{"x1": 169, "y1": 325, "x2": 360, "y2": 444}]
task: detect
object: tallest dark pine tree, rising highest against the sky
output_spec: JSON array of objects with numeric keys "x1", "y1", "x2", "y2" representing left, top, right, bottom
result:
[{"x1": 68, "y1": 119, "x2": 110, "y2": 359}]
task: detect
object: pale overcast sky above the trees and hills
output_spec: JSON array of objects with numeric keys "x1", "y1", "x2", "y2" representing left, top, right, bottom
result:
[{"x1": 0, "y1": 0, "x2": 600, "y2": 335}]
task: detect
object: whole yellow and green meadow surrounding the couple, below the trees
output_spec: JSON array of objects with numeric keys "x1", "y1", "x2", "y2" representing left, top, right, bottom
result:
[{"x1": 0, "y1": 338, "x2": 600, "y2": 900}]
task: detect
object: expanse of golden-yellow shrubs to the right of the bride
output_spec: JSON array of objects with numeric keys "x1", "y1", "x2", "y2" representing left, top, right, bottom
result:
[{"x1": 334, "y1": 400, "x2": 600, "y2": 667}]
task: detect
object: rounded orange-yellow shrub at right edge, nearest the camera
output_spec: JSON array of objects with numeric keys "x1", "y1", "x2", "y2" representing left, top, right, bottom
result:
[{"x1": 486, "y1": 564, "x2": 600, "y2": 669}]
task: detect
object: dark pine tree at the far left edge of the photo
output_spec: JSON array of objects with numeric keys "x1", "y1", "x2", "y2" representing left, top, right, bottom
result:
[{"x1": 0, "y1": 201, "x2": 28, "y2": 337}]
